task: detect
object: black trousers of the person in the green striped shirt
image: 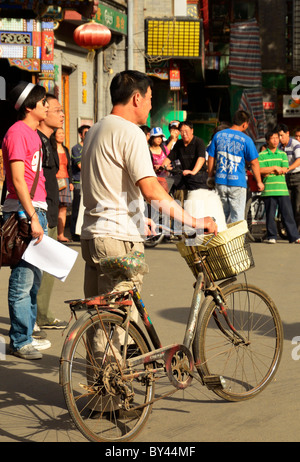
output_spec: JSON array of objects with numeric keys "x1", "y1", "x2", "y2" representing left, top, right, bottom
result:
[{"x1": 264, "y1": 196, "x2": 300, "y2": 242}]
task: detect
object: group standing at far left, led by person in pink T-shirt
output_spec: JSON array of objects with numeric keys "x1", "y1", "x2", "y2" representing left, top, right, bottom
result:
[{"x1": 2, "y1": 82, "x2": 89, "y2": 359}]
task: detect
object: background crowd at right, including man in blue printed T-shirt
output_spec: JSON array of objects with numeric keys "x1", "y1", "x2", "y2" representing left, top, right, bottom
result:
[{"x1": 141, "y1": 111, "x2": 300, "y2": 244}]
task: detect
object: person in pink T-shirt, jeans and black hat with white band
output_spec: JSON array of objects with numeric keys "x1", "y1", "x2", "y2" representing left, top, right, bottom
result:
[{"x1": 2, "y1": 82, "x2": 51, "y2": 359}]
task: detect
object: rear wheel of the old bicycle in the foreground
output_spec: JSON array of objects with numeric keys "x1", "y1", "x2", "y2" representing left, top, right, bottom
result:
[{"x1": 60, "y1": 312, "x2": 154, "y2": 442}]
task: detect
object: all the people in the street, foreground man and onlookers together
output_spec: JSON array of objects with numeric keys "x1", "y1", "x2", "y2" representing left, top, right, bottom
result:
[{"x1": 2, "y1": 71, "x2": 300, "y2": 359}]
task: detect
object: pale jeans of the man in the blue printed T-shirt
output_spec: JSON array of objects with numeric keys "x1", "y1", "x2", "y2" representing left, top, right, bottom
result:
[{"x1": 216, "y1": 184, "x2": 247, "y2": 223}]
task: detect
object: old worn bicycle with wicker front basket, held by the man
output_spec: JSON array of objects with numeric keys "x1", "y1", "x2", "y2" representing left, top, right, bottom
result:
[{"x1": 60, "y1": 222, "x2": 283, "y2": 442}]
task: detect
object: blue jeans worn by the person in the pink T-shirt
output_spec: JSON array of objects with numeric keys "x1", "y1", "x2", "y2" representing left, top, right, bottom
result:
[{"x1": 3, "y1": 209, "x2": 47, "y2": 350}]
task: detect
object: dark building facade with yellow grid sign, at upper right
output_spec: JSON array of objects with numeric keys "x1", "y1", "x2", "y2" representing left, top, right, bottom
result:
[{"x1": 144, "y1": 0, "x2": 300, "y2": 142}]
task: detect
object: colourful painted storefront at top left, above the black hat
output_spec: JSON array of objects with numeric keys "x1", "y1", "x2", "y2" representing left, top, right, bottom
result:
[{"x1": 0, "y1": 0, "x2": 98, "y2": 183}]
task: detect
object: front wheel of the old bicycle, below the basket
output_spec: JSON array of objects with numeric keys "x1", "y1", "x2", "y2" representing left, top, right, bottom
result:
[{"x1": 193, "y1": 284, "x2": 283, "y2": 401}]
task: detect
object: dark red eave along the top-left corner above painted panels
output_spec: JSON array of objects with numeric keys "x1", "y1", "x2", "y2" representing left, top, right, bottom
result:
[{"x1": 0, "y1": 0, "x2": 99, "y2": 18}]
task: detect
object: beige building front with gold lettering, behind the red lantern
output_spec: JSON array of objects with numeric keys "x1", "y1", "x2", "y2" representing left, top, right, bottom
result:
[{"x1": 54, "y1": 2, "x2": 127, "y2": 147}]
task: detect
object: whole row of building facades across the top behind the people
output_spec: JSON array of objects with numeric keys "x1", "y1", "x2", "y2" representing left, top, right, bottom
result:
[{"x1": 0, "y1": 0, "x2": 300, "y2": 153}]
